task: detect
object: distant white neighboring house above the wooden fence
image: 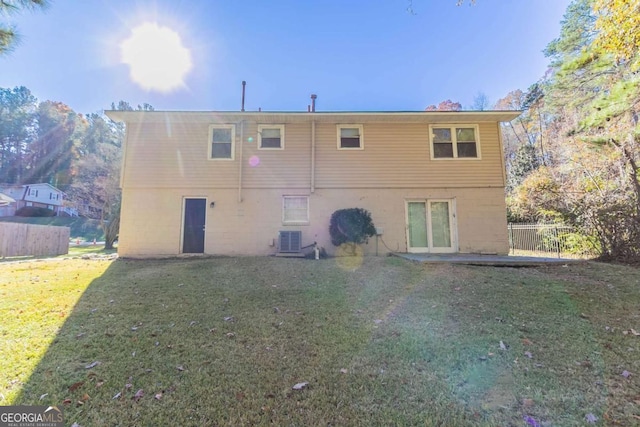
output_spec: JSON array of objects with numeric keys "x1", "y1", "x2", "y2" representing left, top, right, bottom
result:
[{"x1": 0, "y1": 183, "x2": 78, "y2": 216}]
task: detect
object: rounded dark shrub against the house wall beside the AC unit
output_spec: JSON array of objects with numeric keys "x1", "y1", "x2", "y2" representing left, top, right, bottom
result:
[{"x1": 329, "y1": 208, "x2": 376, "y2": 246}]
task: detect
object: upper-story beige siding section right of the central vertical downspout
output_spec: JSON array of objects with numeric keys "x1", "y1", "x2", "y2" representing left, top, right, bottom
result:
[{"x1": 316, "y1": 122, "x2": 504, "y2": 188}]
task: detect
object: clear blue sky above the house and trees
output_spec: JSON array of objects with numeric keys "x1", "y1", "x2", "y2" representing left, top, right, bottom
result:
[{"x1": 0, "y1": 0, "x2": 569, "y2": 113}]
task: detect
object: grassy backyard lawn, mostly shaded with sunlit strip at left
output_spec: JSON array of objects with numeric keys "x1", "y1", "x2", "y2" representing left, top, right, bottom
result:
[{"x1": 0, "y1": 257, "x2": 640, "y2": 427}]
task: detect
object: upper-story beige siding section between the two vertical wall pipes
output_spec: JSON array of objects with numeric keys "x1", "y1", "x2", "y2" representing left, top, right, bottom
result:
[{"x1": 242, "y1": 123, "x2": 311, "y2": 188}]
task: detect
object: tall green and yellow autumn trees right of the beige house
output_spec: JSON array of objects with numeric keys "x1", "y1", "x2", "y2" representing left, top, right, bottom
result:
[{"x1": 495, "y1": 0, "x2": 640, "y2": 262}]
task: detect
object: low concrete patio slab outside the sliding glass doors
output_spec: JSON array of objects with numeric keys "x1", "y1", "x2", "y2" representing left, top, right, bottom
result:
[{"x1": 392, "y1": 252, "x2": 587, "y2": 267}]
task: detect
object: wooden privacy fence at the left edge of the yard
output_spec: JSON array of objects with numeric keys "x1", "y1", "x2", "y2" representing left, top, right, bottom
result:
[{"x1": 0, "y1": 222, "x2": 69, "y2": 257}]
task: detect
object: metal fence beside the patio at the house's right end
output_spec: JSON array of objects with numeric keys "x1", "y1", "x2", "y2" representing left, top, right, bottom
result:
[{"x1": 508, "y1": 223, "x2": 597, "y2": 258}]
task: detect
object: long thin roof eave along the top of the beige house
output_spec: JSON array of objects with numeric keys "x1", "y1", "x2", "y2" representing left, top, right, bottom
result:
[{"x1": 105, "y1": 110, "x2": 522, "y2": 123}]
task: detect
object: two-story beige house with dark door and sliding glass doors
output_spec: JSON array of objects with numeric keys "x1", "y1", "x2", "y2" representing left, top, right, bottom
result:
[{"x1": 107, "y1": 111, "x2": 519, "y2": 257}]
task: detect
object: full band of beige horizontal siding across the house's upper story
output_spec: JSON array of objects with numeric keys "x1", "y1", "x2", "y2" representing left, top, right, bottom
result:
[{"x1": 123, "y1": 121, "x2": 504, "y2": 189}]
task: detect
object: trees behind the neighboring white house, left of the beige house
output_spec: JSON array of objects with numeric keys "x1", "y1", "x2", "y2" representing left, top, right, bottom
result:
[{"x1": 0, "y1": 86, "x2": 153, "y2": 248}]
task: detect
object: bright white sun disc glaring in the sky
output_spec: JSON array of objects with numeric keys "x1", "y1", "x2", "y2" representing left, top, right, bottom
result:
[{"x1": 120, "y1": 22, "x2": 193, "y2": 92}]
